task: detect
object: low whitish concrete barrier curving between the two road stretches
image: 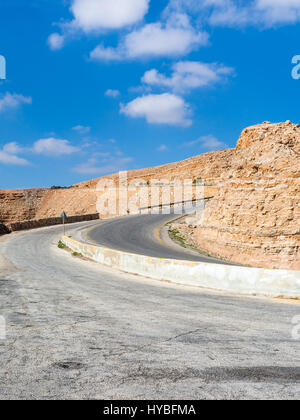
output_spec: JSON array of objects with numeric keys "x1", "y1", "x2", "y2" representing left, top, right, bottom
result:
[{"x1": 62, "y1": 236, "x2": 300, "y2": 298}]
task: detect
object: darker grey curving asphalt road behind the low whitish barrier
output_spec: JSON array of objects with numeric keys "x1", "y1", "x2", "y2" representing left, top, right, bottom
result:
[{"x1": 83, "y1": 214, "x2": 232, "y2": 264}]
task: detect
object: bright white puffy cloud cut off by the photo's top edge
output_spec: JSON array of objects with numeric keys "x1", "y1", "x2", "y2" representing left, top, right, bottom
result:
[{"x1": 70, "y1": 0, "x2": 150, "y2": 33}]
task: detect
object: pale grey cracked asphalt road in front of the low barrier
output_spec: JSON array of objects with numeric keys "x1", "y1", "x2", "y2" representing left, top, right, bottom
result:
[{"x1": 0, "y1": 222, "x2": 300, "y2": 400}]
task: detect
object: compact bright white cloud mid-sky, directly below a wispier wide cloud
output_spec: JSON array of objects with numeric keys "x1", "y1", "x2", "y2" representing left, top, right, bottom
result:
[{"x1": 120, "y1": 93, "x2": 192, "y2": 127}]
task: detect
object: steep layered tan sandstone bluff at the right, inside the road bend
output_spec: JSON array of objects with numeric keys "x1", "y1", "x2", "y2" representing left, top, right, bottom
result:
[{"x1": 191, "y1": 122, "x2": 300, "y2": 270}]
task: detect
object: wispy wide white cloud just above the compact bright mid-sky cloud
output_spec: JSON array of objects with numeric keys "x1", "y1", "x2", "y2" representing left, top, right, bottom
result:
[{"x1": 142, "y1": 61, "x2": 233, "y2": 92}]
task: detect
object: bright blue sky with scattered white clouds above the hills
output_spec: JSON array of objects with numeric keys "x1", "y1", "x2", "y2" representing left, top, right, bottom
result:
[{"x1": 0, "y1": 0, "x2": 300, "y2": 188}]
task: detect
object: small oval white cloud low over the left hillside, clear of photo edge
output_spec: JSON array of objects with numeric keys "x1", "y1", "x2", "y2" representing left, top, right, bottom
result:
[{"x1": 32, "y1": 137, "x2": 80, "y2": 156}]
